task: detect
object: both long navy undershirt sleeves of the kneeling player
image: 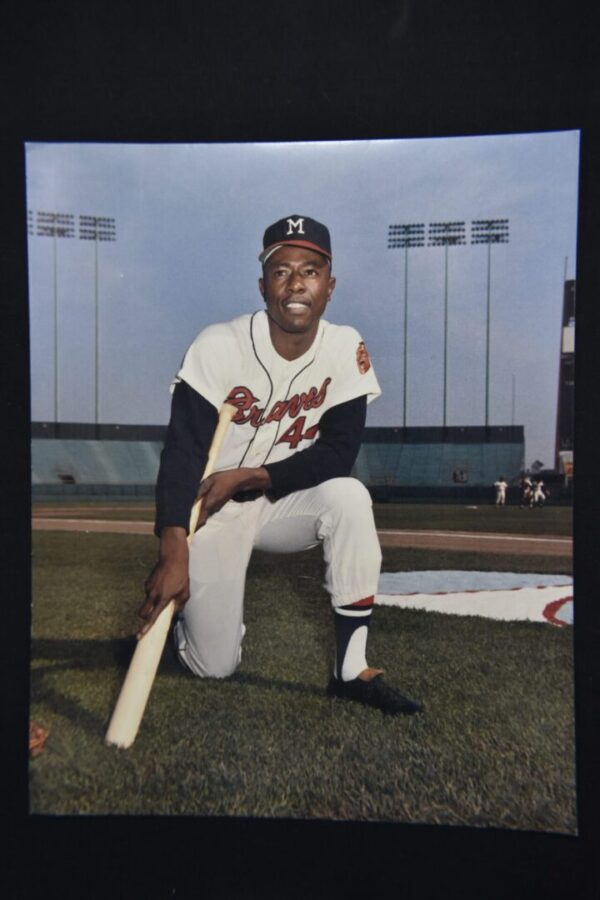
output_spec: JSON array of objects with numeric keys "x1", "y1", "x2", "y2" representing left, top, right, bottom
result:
[{"x1": 154, "y1": 381, "x2": 367, "y2": 536}]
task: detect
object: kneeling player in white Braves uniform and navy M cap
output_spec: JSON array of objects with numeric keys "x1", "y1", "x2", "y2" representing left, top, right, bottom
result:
[{"x1": 138, "y1": 215, "x2": 422, "y2": 715}]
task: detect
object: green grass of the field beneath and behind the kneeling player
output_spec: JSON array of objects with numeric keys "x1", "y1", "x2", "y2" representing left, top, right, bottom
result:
[{"x1": 30, "y1": 507, "x2": 576, "y2": 834}]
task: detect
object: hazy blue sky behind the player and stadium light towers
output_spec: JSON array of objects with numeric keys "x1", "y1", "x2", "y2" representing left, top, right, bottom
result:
[{"x1": 26, "y1": 131, "x2": 579, "y2": 466}]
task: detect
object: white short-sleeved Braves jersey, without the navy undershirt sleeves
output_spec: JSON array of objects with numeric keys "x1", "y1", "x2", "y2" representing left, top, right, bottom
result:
[{"x1": 172, "y1": 310, "x2": 381, "y2": 471}]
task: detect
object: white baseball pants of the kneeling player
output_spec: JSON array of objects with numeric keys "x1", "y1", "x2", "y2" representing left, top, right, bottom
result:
[{"x1": 174, "y1": 478, "x2": 381, "y2": 678}]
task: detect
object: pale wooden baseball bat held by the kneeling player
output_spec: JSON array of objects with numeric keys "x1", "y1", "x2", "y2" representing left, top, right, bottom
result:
[{"x1": 105, "y1": 403, "x2": 236, "y2": 749}]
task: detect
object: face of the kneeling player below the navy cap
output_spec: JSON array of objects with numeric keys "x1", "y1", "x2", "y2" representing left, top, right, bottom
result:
[{"x1": 258, "y1": 247, "x2": 335, "y2": 335}]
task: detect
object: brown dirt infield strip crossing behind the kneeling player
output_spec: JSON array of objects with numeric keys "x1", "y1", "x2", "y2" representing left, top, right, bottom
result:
[{"x1": 32, "y1": 508, "x2": 573, "y2": 557}]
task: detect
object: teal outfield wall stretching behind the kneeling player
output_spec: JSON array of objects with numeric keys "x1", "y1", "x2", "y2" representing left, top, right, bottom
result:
[{"x1": 31, "y1": 422, "x2": 564, "y2": 502}]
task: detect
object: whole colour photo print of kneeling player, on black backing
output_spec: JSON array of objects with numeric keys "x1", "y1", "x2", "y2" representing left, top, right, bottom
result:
[{"x1": 25, "y1": 131, "x2": 580, "y2": 835}]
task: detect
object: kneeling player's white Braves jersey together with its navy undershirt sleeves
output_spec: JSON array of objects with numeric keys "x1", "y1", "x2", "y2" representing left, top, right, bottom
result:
[{"x1": 155, "y1": 311, "x2": 380, "y2": 535}]
